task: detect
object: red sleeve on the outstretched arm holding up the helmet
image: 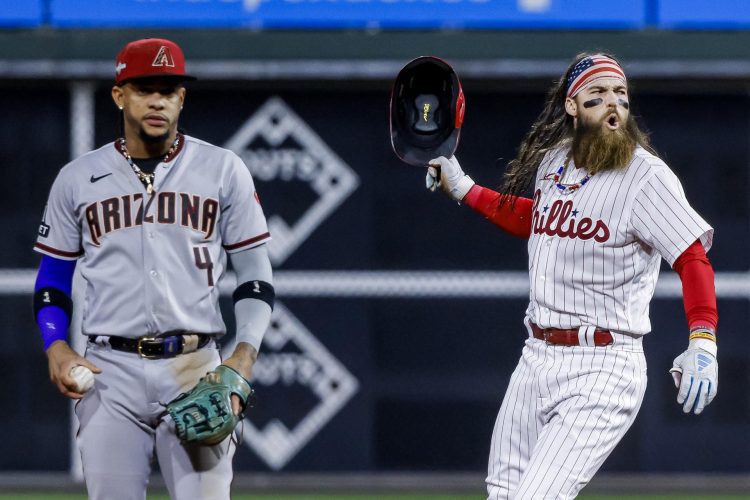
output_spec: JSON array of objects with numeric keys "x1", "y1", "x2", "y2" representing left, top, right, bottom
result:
[{"x1": 463, "y1": 184, "x2": 533, "y2": 239}]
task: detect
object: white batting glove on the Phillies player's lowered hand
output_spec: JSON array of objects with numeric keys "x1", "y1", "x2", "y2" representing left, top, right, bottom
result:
[{"x1": 669, "y1": 339, "x2": 719, "y2": 415}]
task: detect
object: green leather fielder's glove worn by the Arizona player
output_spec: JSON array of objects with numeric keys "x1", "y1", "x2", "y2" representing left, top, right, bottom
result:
[{"x1": 167, "y1": 365, "x2": 253, "y2": 445}]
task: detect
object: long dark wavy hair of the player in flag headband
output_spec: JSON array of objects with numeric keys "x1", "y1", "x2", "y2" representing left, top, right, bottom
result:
[{"x1": 500, "y1": 52, "x2": 654, "y2": 203}]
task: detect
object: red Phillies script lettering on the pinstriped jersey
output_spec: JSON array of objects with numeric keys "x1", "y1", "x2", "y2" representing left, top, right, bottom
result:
[{"x1": 532, "y1": 189, "x2": 609, "y2": 243}]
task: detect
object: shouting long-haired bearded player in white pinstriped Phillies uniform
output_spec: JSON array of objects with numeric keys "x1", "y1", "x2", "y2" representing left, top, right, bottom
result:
[{"x1": 427, "y1": 54, "x2": 718, "y2": 500}]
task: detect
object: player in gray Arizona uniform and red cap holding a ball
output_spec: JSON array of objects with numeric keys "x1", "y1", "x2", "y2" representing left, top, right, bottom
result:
[{"x1": 35, "y1": 39, "x2": 274, "y2": 499}]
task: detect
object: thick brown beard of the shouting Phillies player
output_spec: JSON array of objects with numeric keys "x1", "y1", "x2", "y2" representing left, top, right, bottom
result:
[{"x1": 571, "y1": 116, "x2": 638, "y2": 175}]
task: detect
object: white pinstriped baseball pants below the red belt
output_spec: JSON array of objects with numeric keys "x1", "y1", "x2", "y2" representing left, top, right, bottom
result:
[{"x1": 486, "y1": 333, "x2": 646, "y2": 500}]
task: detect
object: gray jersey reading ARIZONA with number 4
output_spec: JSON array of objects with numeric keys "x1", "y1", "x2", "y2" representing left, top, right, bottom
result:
[{"x1": 34, "y1": 136, "x2": 270, "y2": 337}]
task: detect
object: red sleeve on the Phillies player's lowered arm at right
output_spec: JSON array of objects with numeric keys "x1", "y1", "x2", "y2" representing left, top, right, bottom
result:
[{"x1": 672, "y1": 240, "x2": 719, "y2": 331}]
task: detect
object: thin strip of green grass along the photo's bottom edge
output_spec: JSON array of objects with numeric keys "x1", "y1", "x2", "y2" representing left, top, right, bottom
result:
[{"x1": 0, "y1": 492, "x2": 748, "y2": 500}]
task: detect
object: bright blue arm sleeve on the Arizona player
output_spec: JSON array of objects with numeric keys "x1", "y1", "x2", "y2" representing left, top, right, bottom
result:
[{"x1": 34, "y1": 255, "x2": 76, "y2": 351}]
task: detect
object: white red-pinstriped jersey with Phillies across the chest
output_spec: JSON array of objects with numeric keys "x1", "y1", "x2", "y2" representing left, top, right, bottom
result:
[{"x1": 526, "y1": 143, "x2": 713, "y2": 335}]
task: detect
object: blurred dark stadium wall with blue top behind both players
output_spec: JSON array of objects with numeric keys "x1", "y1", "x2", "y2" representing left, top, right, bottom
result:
[{"x1": 0, "y1": 0, "x2": 750, "y2": 498}]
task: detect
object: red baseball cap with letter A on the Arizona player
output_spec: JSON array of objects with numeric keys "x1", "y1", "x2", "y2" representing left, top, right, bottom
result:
[{"x1": 115, "y1": 38, "x2": 195, "y2": 85}]
